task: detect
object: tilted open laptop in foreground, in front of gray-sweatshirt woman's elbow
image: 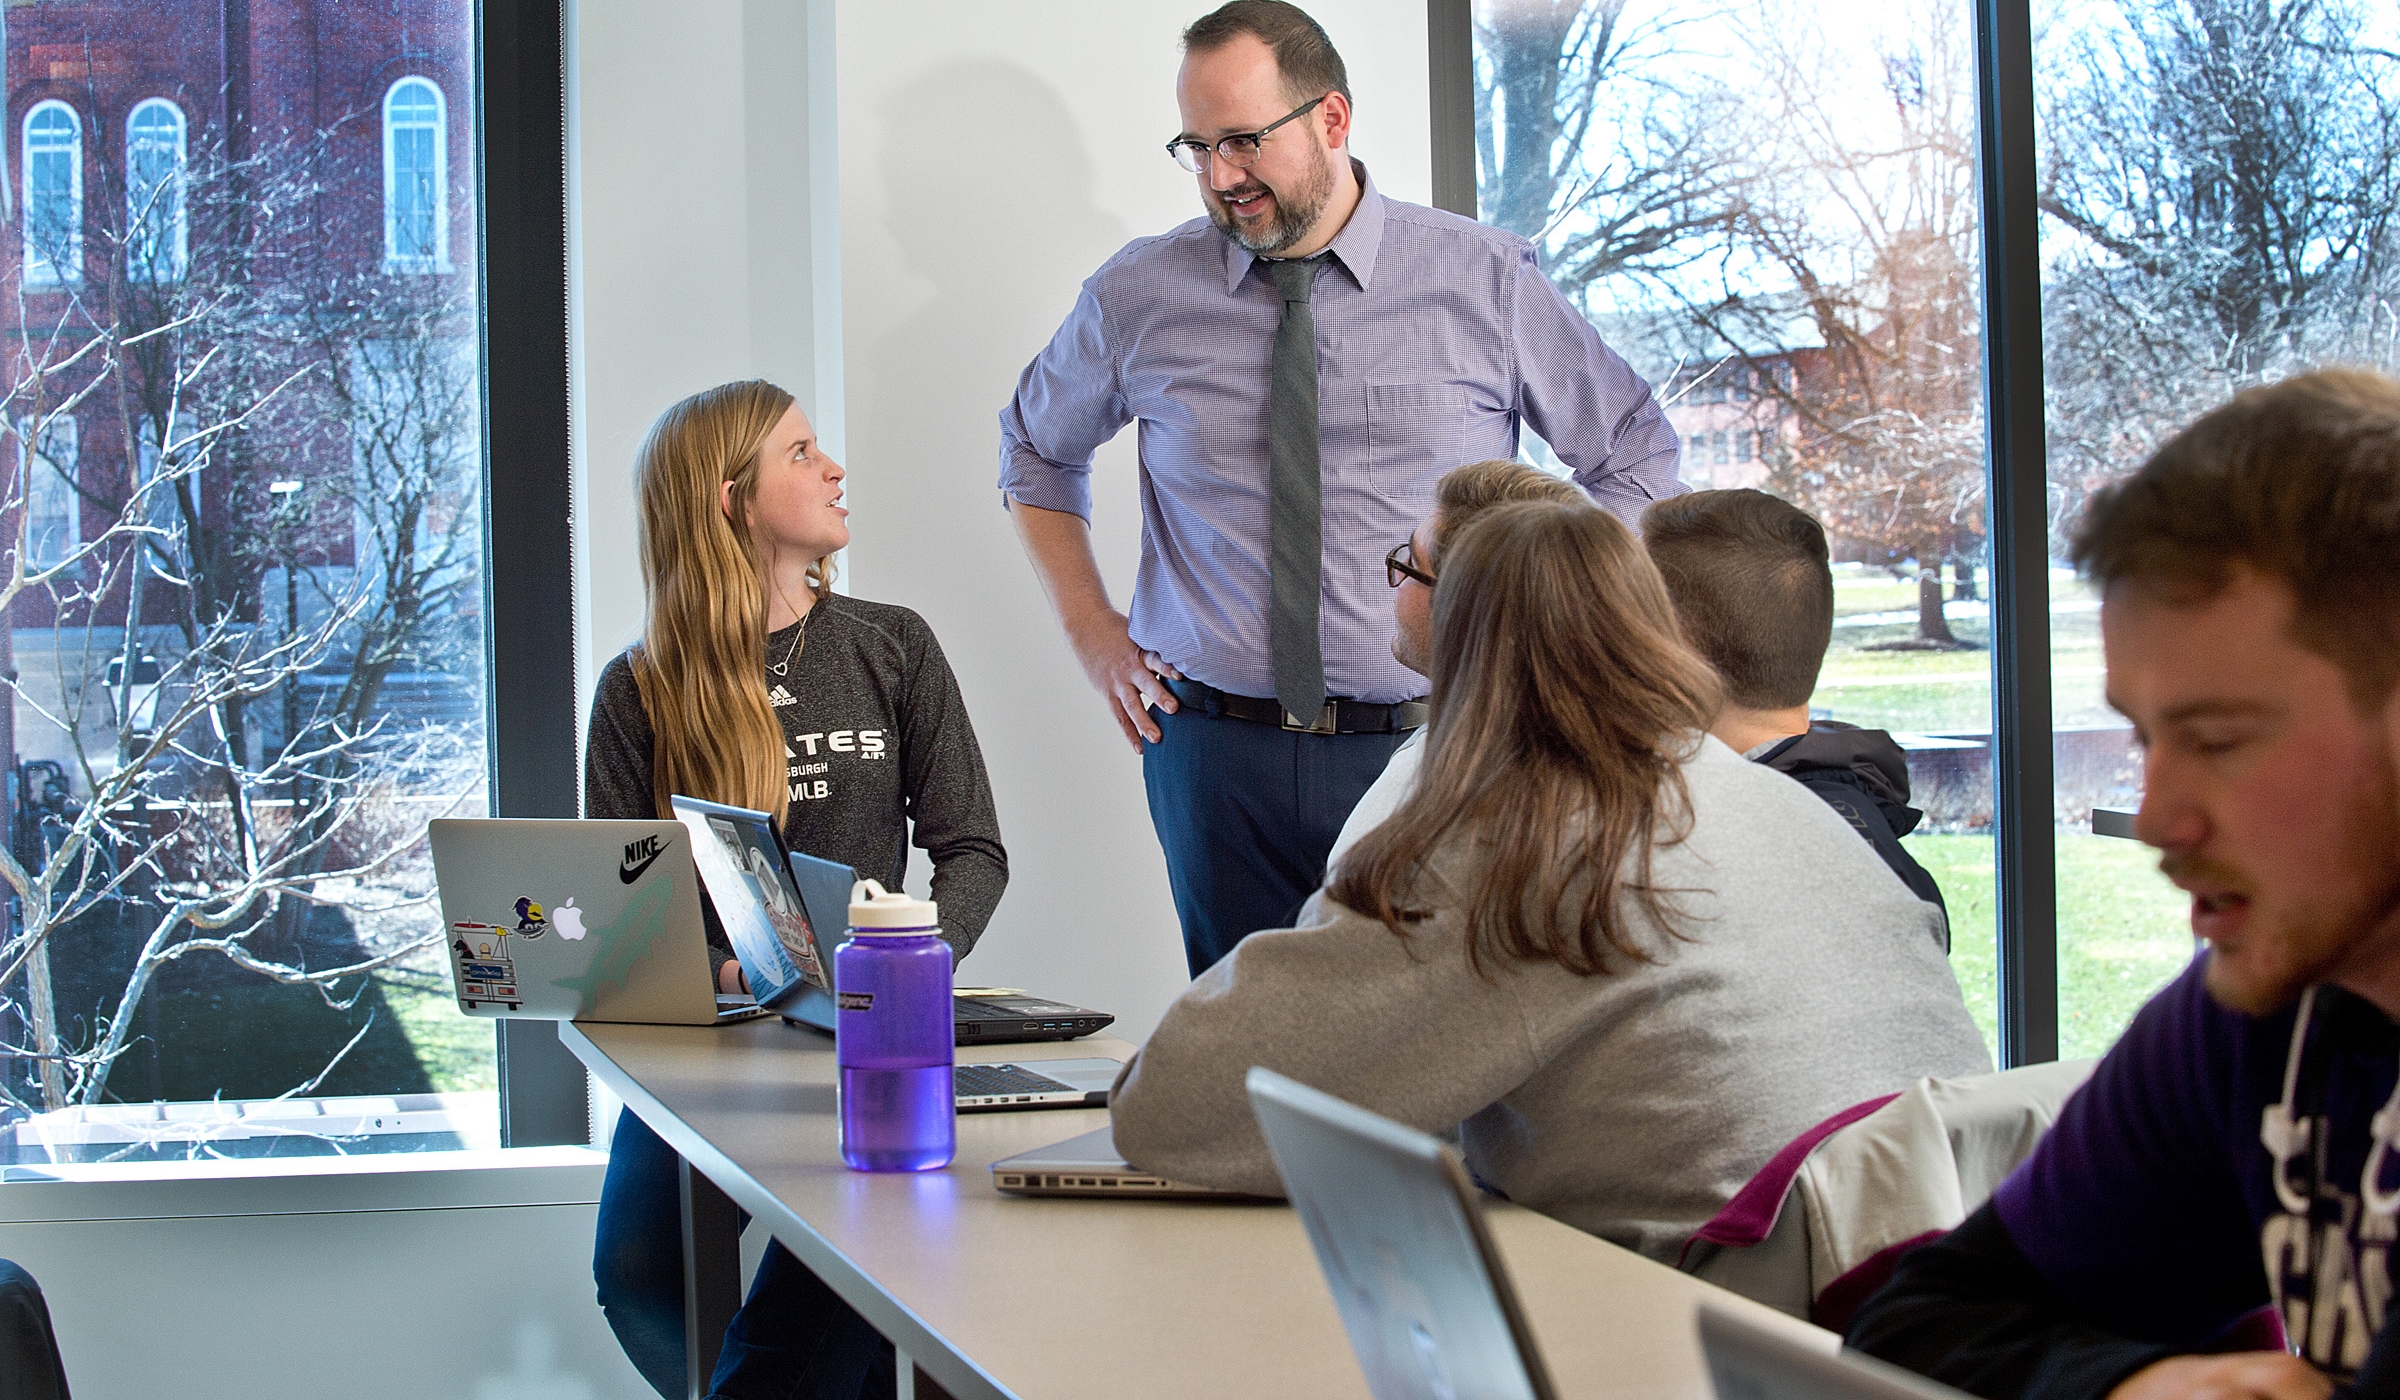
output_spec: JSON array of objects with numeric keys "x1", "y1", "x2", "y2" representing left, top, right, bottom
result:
[{"x1": 1246, "y1": 1066, "x2": 1558, "y2": 1400}]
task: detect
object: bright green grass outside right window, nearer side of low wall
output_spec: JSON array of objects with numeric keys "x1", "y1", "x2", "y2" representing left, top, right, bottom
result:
[{"x1": 1903, "y1": 828, "x2": 2191, "y2": 1059}]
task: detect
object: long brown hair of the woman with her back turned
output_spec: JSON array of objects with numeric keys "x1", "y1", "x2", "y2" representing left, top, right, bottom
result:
[{"x1": 1327, "y1": 502, "x2": 1721, "y2": 977}]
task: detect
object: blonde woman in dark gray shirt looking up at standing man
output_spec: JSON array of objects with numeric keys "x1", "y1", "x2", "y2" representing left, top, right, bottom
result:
[{"x1": 583, "y1": 379, "x2": 1008, "y2": 1398}]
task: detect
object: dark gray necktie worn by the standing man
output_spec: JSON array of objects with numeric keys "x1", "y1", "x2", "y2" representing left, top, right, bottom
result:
[{"x1": 1260, "y1": 259, "x2": 1325, "y2": 723}]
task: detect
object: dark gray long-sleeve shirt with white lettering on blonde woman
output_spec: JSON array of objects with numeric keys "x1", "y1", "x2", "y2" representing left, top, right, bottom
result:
[{"x1": 583, "y1": 593, "x2": 1008, "y2": 965}]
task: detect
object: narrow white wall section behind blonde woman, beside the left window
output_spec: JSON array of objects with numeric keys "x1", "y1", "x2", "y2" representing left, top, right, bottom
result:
[{"x1": 566, "y1": 0, "x2": 842, "y2": 686}]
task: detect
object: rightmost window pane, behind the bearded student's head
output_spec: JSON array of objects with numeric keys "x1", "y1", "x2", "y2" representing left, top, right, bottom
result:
[{"x1": 2033, "y1": 0, "x2": 2400, "y2": 1054}]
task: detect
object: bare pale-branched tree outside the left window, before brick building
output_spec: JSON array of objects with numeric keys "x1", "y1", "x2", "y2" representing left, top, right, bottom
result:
[{"x1": 0, "y1": 103, "x2": 480, "y2": 1112}]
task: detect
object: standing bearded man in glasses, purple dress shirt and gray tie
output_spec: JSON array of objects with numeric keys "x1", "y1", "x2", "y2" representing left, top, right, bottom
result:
[{"x1": 1001, "y1": 0, "x2": 1682, "y2": 975}]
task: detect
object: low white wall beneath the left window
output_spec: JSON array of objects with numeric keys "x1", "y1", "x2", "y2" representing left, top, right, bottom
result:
[{"x1": 0, "y1": 1148, "x2": 650, "y2": 1400}]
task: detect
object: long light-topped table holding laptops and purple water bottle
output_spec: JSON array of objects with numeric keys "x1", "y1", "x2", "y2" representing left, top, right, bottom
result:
[{"x1": 562, "y1": 1021, "x2": 1824, "y2": 1400}]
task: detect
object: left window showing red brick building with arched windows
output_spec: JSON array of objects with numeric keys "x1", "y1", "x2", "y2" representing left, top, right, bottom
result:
[{"x1": 0, "y1": 0, "x2": 501, "y2": 1167}]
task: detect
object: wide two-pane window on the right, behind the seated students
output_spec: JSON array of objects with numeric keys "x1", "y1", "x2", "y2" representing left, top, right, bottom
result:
[{"x1": 1435, "y1": 0, "x2": 2400, "y2": 1059}]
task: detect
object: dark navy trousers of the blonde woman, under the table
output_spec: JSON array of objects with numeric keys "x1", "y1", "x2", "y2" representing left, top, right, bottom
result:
[{"x1": 593, "y1": 1109, "x2": 898, "y2": 1400}]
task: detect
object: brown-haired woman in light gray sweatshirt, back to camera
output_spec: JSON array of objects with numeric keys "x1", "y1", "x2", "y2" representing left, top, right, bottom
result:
[{"x1": 1111, "y1": 502, "x2": 1992, "y2": 1261}]
